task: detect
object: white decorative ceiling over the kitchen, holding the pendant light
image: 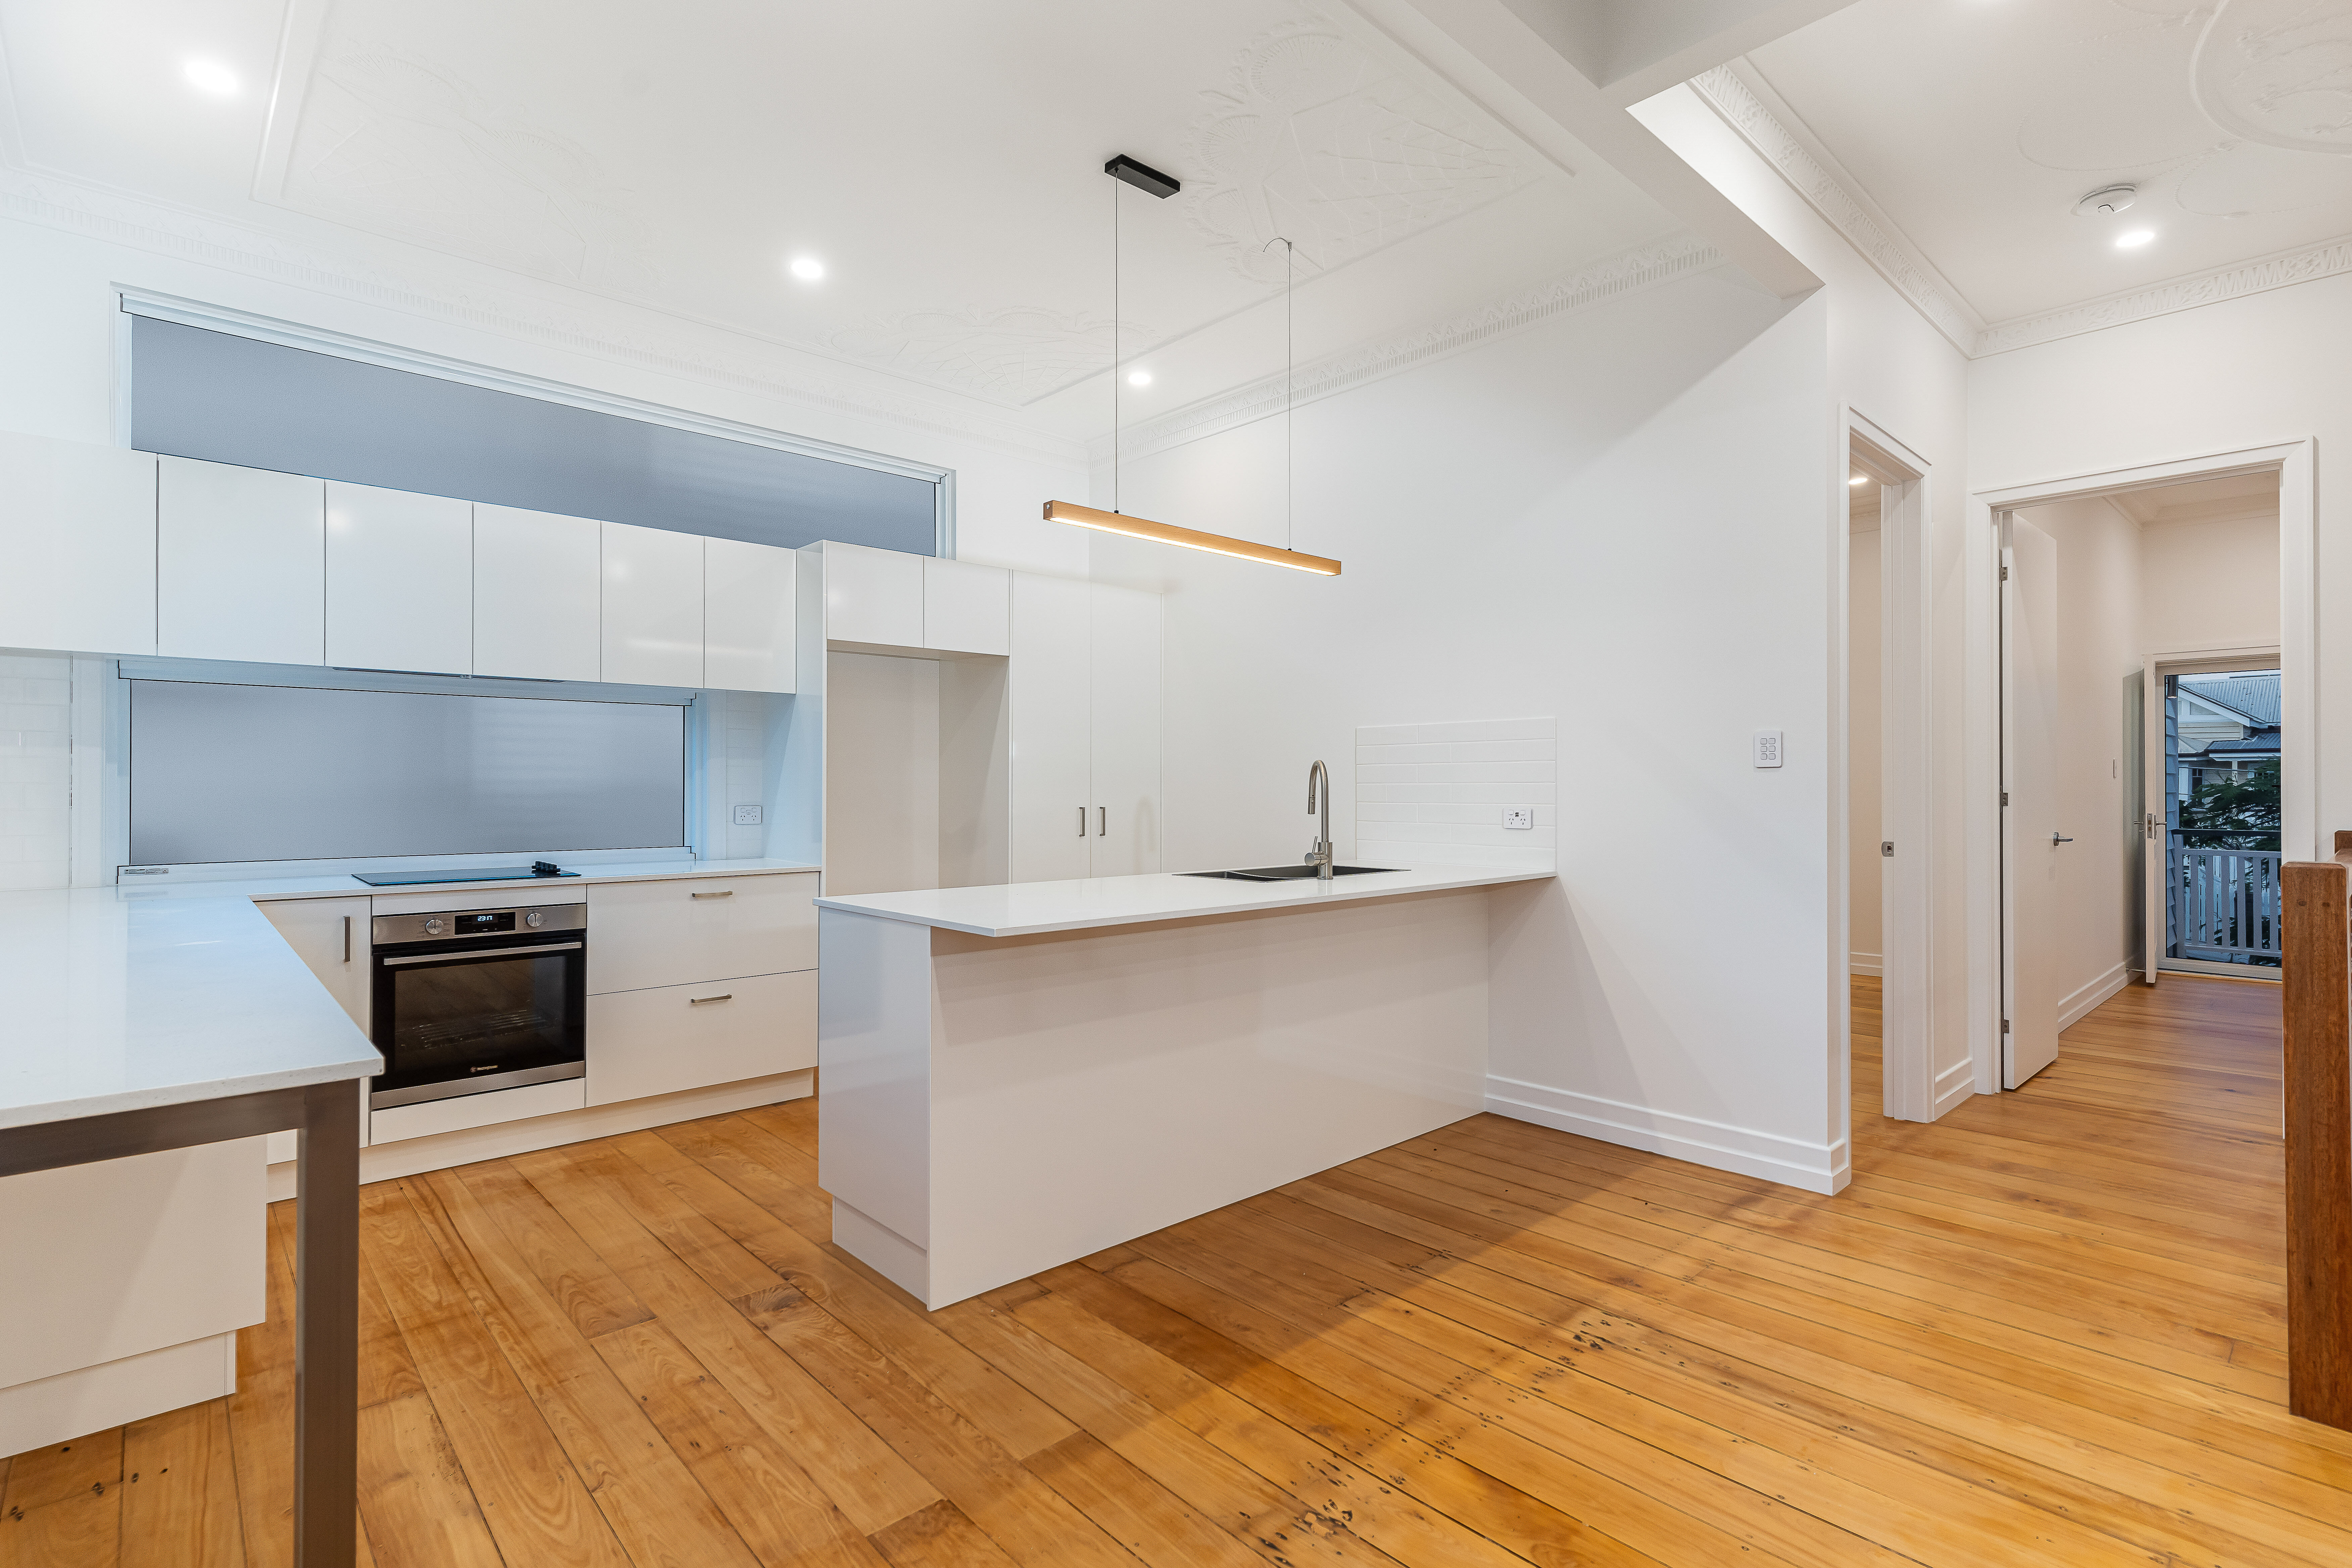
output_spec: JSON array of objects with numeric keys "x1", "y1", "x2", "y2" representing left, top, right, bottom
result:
[{"x1": 0, "y1": 0, "x2": 1675, "y2": 435}]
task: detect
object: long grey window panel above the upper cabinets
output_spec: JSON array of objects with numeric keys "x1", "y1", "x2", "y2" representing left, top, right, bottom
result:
[{"x1": 132, "y1": 315, "x2": 938, "y2": 555}]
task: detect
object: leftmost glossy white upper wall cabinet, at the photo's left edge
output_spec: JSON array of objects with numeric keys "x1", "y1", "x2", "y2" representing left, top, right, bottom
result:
[{"x1": 0, "y1": 435, "x2": 155, "y2": 653}]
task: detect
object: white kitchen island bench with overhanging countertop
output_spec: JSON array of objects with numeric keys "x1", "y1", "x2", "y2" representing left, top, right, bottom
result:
[{"x1": 816, "y1": 865, "x2": 1552, "y2": 1310}]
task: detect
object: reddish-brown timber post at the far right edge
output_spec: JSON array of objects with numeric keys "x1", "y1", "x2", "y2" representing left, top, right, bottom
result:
[{"x1": 2279, "y1": 832, "x2": 2352, "y2": 1429}]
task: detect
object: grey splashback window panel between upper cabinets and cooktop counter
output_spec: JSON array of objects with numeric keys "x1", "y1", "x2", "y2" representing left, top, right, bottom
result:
[{"x1": 129, "y1": 679, "x2": 687, "y2": 865}]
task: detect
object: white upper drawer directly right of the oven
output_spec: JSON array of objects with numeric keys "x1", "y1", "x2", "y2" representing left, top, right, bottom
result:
[{"x1": 588, "y1": 872, "x2": 816, "y2": 994}]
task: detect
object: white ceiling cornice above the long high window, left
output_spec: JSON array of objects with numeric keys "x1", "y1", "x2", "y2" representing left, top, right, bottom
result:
[{"x1": 0, "y1": 169, "x2": 1084, "y2": 468}]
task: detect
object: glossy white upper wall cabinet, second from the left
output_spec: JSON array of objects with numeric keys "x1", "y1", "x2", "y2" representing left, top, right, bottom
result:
[{"x1": 155, "y1": 458, "x2": 327, "y2": 665}]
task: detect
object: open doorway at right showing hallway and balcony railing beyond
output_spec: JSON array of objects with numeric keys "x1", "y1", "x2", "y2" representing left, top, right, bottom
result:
[{"x1": 1995, "y1": 466, "x2": 2300, "y2": 1088}]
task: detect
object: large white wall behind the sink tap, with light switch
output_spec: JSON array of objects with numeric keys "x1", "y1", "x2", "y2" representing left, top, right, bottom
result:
[{"x1": 1094, "y1": 278, "x2": 1844, "y2": 1189}]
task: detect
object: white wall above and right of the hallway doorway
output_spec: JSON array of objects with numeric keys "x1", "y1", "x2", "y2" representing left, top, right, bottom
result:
[{"x1": 1969, "y1": 278, "x2": 2352, "y2": 858}]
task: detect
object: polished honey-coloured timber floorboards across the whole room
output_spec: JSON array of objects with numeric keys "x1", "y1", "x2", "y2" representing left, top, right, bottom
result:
[{"x1": 14, "y1": 976, "x2": 2352, "y2": 1568}]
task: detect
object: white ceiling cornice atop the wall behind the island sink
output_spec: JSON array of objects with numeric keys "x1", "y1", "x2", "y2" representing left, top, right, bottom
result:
[{"x1": 1089, "y1": 235, "x2": 1726, "y2": 463}]
